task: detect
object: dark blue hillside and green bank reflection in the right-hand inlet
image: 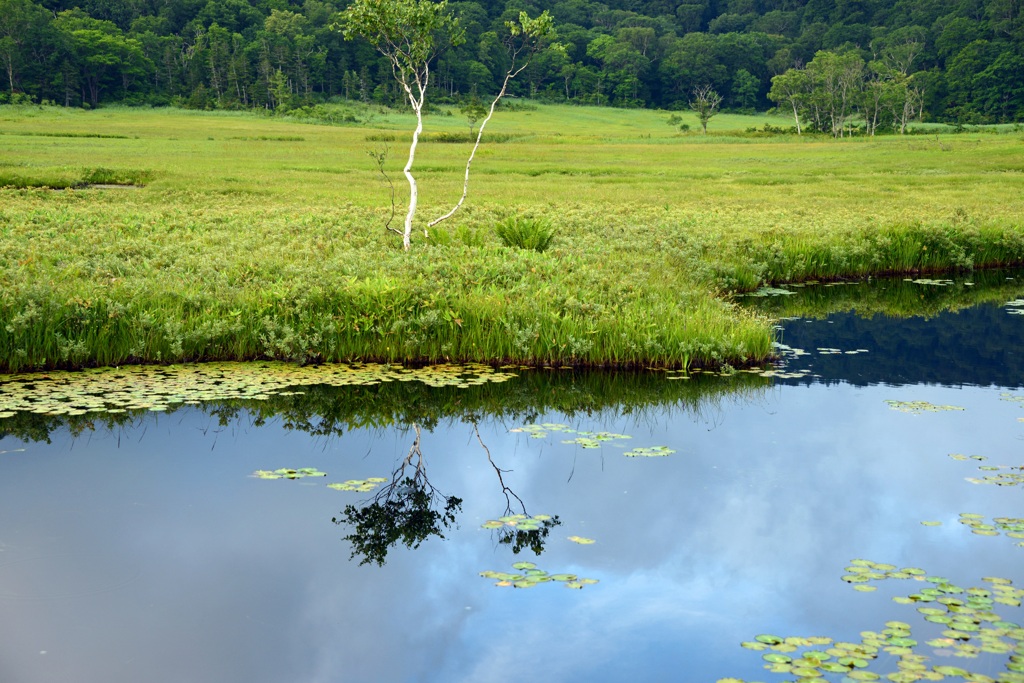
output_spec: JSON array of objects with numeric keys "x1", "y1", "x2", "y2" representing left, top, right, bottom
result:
[{"x1": 759, "y1": 271, "x2": 1024, "y2": 387}]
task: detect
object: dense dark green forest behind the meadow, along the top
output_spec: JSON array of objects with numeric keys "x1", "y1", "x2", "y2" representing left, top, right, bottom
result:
[{"x1": 0, "y1": 0, "x2": 1024, "y2": 123}]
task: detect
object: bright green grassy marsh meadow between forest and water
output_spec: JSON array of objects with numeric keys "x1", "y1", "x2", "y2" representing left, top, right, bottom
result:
[{"x1": 0, "y1": 104, "x2": 1024, "y2": 372}]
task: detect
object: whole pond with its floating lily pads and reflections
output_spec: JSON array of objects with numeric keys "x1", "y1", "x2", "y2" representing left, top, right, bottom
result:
[{"x1": 0, "y1": 273, "x2": 1024, "y2": 683}]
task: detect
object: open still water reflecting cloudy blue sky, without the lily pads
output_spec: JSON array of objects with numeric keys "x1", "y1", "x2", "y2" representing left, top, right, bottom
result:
[{"x1": 0, "y1": 274, "x2": 1024, "y2": 683}]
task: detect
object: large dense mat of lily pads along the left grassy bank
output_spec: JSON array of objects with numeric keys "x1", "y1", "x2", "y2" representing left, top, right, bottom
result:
[{"x1": 0, "y1": 362, "x2": 516, "y2": 419}]
